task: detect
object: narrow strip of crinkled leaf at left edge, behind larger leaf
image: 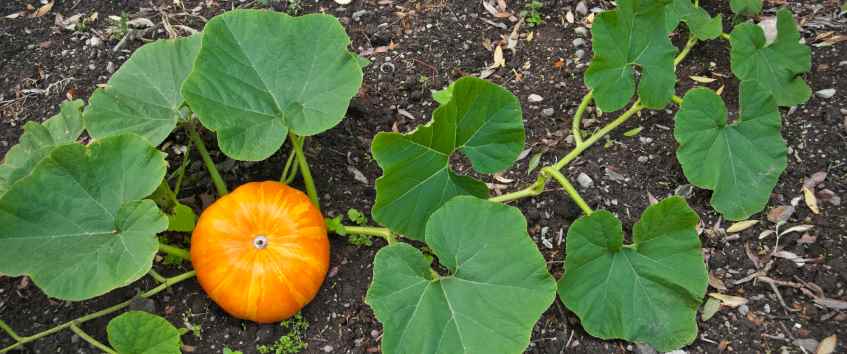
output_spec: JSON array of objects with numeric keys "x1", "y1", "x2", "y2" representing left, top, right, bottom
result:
[{"x1": 0, "y1": 100, "x2": 85, "y2": 196}]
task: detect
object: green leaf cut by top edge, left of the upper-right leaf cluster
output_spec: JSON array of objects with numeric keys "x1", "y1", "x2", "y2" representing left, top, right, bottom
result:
[{"x1": 585, "y1": 0, "x2": 677, "y2": 112}]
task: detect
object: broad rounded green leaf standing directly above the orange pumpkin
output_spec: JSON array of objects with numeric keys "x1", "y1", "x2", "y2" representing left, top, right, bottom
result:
[{"x1": 182, "y1": 10, "x2": 362, "y2": 161}]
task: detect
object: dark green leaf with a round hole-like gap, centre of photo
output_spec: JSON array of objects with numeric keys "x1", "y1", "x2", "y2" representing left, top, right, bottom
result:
[{"x1": 371, "y1": 77, "x2": 525, "y2": 240}]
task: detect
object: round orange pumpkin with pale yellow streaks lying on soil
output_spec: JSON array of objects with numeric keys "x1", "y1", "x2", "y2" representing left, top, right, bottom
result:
[{"x1": 191, "y1": 182, "x2": 329, "y2": 323}]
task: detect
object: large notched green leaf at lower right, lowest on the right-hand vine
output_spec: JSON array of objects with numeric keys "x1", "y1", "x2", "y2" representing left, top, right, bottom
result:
[{"x1": 559, "y1": 197, "x2": 708, "y2": 352}]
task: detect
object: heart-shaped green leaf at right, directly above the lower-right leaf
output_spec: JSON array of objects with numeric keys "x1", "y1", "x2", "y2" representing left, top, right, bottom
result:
[{"x1": 674, "y1": 81, "x2": 788, "y2": 220}]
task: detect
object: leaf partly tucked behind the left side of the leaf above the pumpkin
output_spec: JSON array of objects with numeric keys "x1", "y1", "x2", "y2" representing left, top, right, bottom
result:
[{"x1": 85, "y1": 34, "x2": 201, "y2": 145}]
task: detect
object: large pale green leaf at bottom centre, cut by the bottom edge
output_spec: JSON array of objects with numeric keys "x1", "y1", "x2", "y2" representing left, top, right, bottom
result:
[{"x1": 366, "y1": 196, "x2": 556, "y2": 354}]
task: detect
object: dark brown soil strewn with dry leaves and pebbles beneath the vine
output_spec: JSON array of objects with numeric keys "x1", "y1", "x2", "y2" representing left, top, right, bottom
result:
[{"x1": 0, "y1": 0, "x2": 847, "y2": 353}]
